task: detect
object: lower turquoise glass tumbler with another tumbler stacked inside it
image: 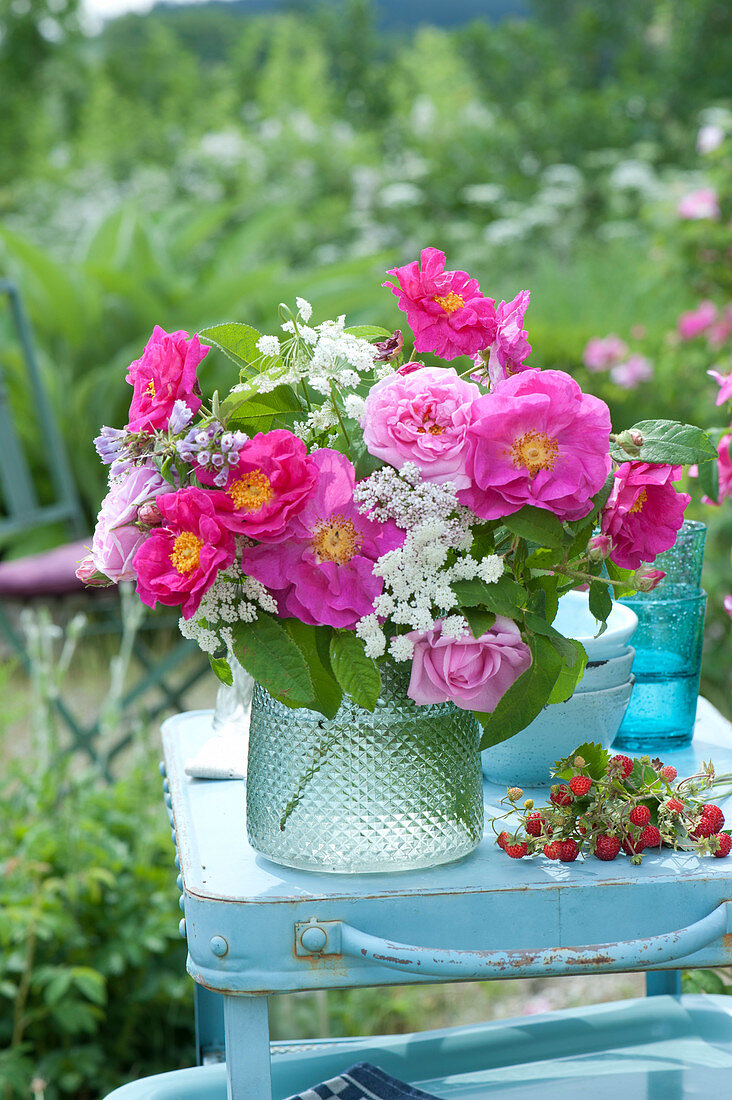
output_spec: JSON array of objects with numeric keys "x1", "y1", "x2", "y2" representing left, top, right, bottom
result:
[{"x1": 612, "y1": 590, "x2": 707, "y2": 756}]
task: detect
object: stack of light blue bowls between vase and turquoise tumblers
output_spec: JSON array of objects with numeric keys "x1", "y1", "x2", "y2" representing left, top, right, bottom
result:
[{"x1": 481, "y1": 592, "x2": 637, "y2": 788}]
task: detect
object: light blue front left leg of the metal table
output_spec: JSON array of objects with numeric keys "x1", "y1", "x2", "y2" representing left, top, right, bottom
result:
[{"x1": 223, "y1": 997, "x2": 272, "y2": 1100}]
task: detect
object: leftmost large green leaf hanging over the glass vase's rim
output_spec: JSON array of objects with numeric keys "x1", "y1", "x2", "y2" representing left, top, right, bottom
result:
[{"x1": 232, "y1": 612, "x2": 319, "y2": 710}]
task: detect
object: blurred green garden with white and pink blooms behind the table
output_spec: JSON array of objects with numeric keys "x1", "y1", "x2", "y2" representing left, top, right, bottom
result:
[{"x1": 0, "y1": 0, "x2": 732, "y2": 1100}]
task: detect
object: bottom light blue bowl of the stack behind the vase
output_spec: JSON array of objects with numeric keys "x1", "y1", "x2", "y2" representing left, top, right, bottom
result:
[{"x1": 481, "y1": 677, "x2": 633, "y2": 787}]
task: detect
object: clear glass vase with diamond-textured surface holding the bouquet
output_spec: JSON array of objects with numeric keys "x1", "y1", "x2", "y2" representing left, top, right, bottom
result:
[{"x1": 247, "y1": 664, "x2": 483, "y2": 872}]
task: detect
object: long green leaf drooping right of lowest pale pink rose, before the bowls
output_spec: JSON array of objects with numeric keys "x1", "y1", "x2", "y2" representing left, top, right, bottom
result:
[{"x1": 473, "y1": 635, "x2": 562, "y2": 749}]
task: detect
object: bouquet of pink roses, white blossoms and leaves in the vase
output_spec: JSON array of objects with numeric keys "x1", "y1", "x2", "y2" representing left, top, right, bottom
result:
[{"x1": 79, "y1": 248, "x2": 713, "y2": 747}]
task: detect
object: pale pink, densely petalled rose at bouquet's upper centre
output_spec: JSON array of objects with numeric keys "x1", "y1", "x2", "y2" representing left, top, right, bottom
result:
[{"x1": 361, "y1": 366, "x2": 481, "y2": 488}]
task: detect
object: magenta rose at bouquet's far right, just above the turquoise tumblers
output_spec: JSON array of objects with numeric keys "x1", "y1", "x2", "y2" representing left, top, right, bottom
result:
[{"x1": 602, "y1": 462, "x2": 691, "y2": 569}]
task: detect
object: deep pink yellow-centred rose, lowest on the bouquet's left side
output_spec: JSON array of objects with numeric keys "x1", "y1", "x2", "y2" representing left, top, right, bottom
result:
[{"x1": 133, "y1": 487, "x2": 236, "y2": 618}]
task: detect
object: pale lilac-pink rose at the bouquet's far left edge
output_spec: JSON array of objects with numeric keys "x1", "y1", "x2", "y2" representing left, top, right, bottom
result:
[{"x1": 90, "y1": 466, "x2": 172, "y2": 583}]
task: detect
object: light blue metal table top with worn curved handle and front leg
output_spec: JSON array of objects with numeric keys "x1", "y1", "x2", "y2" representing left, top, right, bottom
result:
[{"x1": 155, "y1": 700, "x2": 732, "y2": 1100}]
